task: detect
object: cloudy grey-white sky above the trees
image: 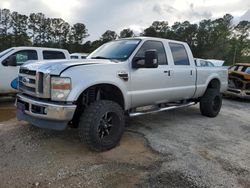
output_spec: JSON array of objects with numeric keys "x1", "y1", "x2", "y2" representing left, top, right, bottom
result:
[{"x1": 0, "y1": 0, "x2": 250, "y2": 40}]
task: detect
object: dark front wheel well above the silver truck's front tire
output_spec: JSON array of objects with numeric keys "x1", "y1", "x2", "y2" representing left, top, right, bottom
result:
[{"x1": 70, "y1": 84, "x2": 125, "y2": 127}]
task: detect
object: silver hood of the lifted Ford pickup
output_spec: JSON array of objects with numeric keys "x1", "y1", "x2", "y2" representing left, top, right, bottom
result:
[{"x1": 21, "y1": 59, "x2": 115, "y2": 75}]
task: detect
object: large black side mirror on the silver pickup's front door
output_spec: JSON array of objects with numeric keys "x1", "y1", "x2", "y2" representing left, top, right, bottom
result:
[{"x1": 132, "y1": 50, "x2": 158, "y2": 68}]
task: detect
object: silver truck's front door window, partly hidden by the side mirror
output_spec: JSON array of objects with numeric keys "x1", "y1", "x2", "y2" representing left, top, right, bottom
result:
[{"x1": 135, "y1": 41, "x2": 168, "y2": 65}]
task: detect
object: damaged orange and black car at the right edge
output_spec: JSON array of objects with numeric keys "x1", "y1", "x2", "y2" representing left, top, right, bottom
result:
[{"x1": 225, "y1": 63, "x2": 250, "y2": 99}]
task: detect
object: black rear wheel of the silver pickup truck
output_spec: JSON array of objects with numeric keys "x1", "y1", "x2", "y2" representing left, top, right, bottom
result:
[{"x1": 200, "y1": 89, "x2": 222, "y2": 117}]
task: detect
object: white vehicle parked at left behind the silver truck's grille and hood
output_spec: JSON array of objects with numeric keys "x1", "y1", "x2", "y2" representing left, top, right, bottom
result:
[{"x1": 0, "y1": 47, "x2": 70, "y2": 95}]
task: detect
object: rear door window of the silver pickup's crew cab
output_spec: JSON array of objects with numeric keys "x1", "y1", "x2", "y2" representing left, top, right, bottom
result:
[{"x1": 169, "y1": 42, "x2": 190, "y2": 65}]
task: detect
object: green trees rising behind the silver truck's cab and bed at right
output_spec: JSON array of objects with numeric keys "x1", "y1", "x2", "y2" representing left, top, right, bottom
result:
[{"x1": 141, "y1": 14, "x2": 250, "y2": 65}]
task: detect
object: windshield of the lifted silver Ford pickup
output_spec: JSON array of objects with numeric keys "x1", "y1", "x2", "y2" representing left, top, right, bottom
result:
[{"x1": 88, "y1": 39, "x2": 141, "y2": 61}]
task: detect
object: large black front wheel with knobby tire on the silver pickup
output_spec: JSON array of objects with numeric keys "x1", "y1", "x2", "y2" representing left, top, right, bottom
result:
[{"x1": 79, "y1": 100, "x2": 124, "y2": 151}]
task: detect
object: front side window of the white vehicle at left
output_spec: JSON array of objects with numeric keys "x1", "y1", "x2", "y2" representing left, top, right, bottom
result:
[{"x1": 8, "y1": 50, "x2": 38, "y2": 66}]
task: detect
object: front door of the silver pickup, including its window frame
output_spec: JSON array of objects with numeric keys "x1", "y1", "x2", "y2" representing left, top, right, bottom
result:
[{"x1": 129, "y1": 41, "x2": 171, "y2": 107}]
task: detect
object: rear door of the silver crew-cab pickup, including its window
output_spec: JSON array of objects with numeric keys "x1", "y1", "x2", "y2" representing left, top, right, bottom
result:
[{"x1": 169, "y1": 42, "x2": 196, "y2": 100}]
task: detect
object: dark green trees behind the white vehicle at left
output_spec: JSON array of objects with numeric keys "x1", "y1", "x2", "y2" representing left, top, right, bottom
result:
[{"x1": 0, "y1": 9, "x2": 89, "y2": 52}]
